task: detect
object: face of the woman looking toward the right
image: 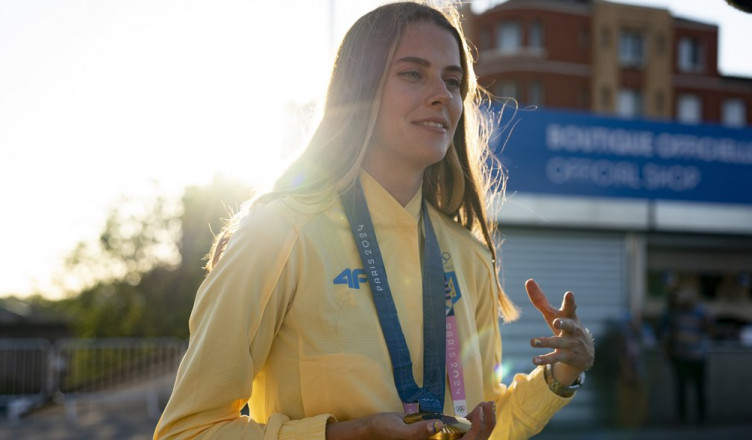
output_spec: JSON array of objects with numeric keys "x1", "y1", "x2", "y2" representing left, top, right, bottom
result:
[{"x1": 366, "y1": 22, "x2": 464, "y2": 180}]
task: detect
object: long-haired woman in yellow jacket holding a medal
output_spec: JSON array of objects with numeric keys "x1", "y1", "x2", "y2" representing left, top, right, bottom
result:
[{"x1": 154, "y1": 2, "x2": 593, "y2": 440}]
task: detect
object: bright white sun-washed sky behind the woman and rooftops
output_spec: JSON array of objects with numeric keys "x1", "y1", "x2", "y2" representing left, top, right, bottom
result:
[{"x1": 0, "y1": 0, "x2": 752, "y2": 297}]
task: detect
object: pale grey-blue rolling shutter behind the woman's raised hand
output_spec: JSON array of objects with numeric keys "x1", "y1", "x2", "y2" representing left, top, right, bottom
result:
[{"x1": 500, "y1": 228, "x2": 629, "y2": 425}]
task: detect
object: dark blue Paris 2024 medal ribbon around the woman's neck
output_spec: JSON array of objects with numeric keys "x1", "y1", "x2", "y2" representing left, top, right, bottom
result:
[{"x1": 342, "y1": 179, "x2": 444, "y2": 414}]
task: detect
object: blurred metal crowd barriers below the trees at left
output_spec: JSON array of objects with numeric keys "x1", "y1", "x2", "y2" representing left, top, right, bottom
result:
[{"x1": 0, "y1": 338, "x2": 186, "y2": 422}]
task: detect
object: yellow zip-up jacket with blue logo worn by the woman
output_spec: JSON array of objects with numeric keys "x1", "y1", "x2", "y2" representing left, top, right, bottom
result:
[{"x1": 159, "y1": 173, "x2": 569, "y2": 440}]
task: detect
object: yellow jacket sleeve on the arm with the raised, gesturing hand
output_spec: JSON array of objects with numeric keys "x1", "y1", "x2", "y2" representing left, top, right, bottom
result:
[{"x1": 475, "y1": 251, "x2": 571, "y2": 440}]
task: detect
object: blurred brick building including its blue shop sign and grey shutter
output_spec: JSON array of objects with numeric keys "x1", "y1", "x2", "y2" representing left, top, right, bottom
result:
[{"x1": 468, "y1": 0, "x2": 752, "y2": 424}]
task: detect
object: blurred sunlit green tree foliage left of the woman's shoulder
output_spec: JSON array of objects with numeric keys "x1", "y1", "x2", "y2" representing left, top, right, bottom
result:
[{"x1": 5, "y1": 174, "x2": 251, "y2": 339}]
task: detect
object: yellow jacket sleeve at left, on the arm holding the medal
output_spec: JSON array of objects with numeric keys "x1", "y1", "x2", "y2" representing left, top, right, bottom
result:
[{"x1": 154, "y1": 207, "x2": 331, "y2": 440}]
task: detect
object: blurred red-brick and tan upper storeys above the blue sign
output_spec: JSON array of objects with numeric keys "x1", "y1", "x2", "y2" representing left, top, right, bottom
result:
[{"x1": 471, "y1": 0, "x2": 752, "y2": 127}]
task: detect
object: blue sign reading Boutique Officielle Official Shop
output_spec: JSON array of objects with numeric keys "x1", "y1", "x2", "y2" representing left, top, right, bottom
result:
[{"x1": 491, "y1": 108, "x2": 752, "y2": 204}]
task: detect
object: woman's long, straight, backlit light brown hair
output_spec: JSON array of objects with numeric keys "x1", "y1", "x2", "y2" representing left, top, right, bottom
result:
[{"x1": 206, "y1": 1, "x2": 518, "y2": 321}]
